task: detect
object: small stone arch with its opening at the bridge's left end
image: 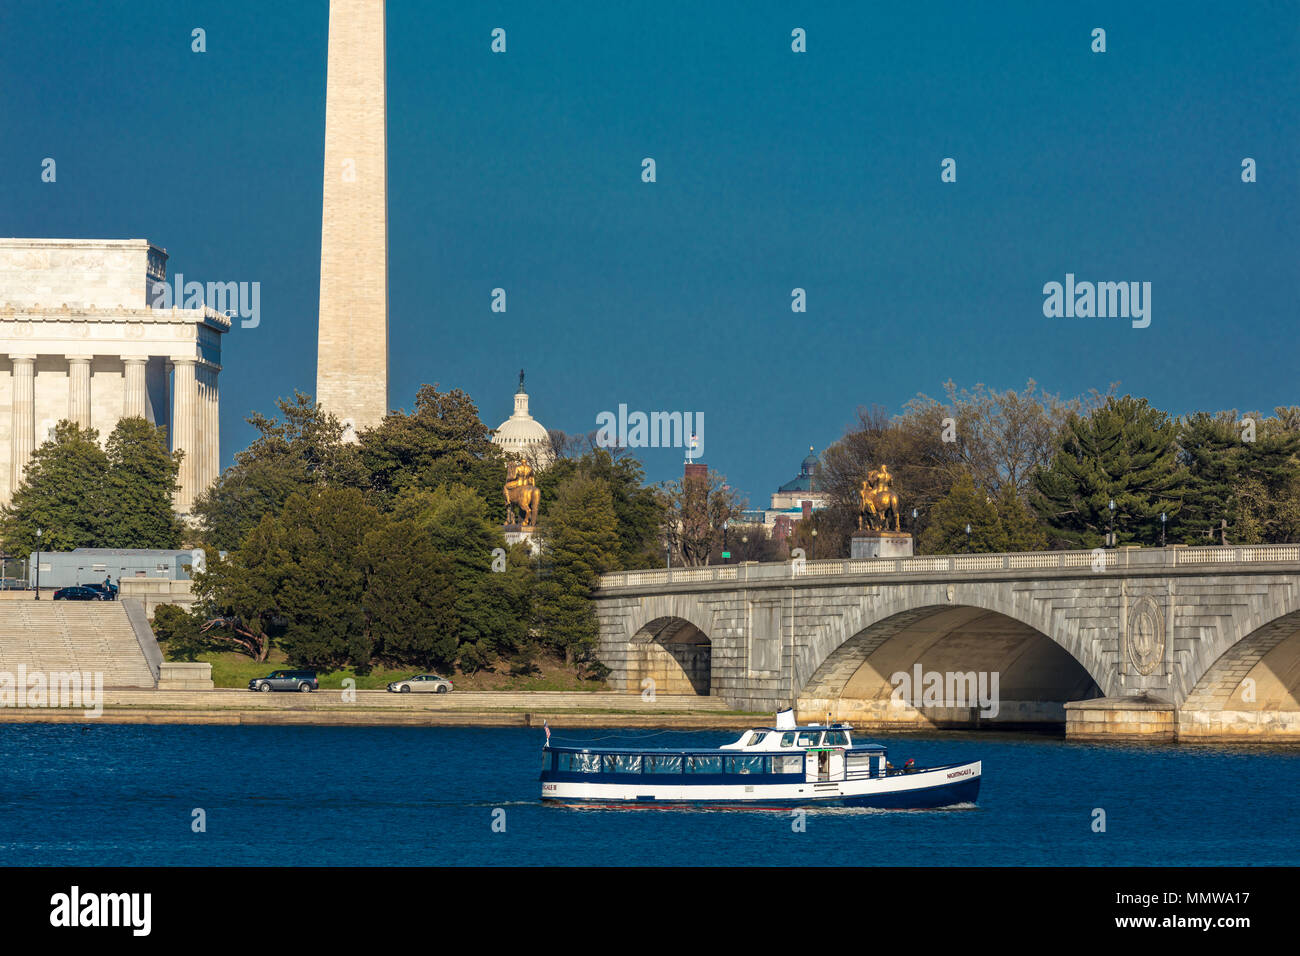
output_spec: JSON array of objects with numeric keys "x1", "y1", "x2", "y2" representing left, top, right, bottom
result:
[{"x1": 625, "y1": 596, "x2": 714, "y2": 696}]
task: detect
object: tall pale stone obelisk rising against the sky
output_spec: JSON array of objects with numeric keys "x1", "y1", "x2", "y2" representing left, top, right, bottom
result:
[{"x1": 316, "y1": 0, "x2": 389, "y2": 438}]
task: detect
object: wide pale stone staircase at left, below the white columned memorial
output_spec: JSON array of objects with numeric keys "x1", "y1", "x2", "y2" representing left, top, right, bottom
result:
[{"x1": 0, "y1": 598, "x2": 155, "y2": 688}]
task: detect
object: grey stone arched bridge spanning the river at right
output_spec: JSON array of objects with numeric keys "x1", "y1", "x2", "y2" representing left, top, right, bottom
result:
[{"x1": 594, "y1": 545, "x2": 1300, "y2": 740}]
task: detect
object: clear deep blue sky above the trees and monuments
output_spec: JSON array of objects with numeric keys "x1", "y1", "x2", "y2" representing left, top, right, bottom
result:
[{"x1": 0, "y1": 0, "x2": 1300, "y2": 505}]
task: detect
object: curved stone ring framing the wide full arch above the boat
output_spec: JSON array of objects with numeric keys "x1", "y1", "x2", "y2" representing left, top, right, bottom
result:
[{"x1": 794, "y1": 581, "x2": 1118, "y2": 696}]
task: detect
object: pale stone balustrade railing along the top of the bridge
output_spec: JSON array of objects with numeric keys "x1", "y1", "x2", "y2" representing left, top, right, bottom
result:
[{"x1": 601, "y1": 545, "x2": 1300, "y2": 591}]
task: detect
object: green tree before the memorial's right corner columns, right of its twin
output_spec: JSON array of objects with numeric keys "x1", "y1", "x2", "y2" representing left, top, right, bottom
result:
[{"x1": 100, "y1": 418, "x2": 183, "y2": 549}]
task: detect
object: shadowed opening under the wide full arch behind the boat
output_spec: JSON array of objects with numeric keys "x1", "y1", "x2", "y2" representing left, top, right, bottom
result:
[{"x1": 798, "y1": 605, "x2": 1102, "y2": 728}]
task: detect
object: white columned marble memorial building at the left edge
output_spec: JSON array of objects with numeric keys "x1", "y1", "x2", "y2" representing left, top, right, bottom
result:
[{"x1": 0, "y1": 239, "x2": 230, "y2": 514}]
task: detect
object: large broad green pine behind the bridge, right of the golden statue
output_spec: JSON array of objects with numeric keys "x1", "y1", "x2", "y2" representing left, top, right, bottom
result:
[{"x1": 1031, "y1": 395, "x2": 1187, "y2": 548}]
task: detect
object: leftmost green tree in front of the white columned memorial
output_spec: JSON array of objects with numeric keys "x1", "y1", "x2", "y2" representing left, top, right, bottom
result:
[{"x1": 0, "y1": 421, "x2": 108, "y2": 554}]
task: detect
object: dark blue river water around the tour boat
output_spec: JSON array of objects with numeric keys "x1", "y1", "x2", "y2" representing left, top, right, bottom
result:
[{"x1": 0, "y1": 724, "x2": 1300, "y2": 866}]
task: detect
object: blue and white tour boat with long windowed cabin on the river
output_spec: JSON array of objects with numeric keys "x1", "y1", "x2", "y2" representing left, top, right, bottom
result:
[{"x1": 541, "y1": 710, "x2": 980, "y2": 810}]
